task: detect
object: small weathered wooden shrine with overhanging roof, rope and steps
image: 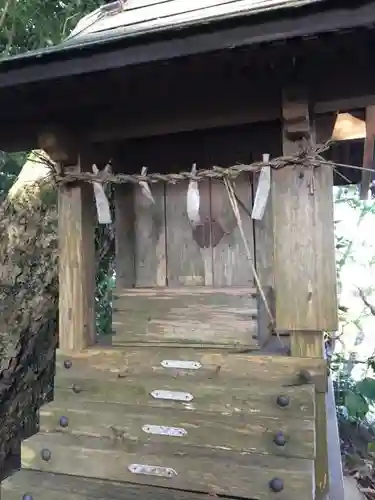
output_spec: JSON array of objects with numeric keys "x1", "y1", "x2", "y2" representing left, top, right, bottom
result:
[{"x1": 0, "y1": 0, "x2": 375, "y2": 500}]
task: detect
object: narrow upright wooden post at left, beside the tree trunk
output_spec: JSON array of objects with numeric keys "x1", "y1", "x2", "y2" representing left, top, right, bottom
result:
[{"x1": 58, "y1": 146, "x2": 96, "y2": 352}]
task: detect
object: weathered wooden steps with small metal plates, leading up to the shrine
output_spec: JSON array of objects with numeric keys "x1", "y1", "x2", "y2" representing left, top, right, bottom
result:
[{"x1": 1, "y1": 345, "x2": 326, "y2": 500}]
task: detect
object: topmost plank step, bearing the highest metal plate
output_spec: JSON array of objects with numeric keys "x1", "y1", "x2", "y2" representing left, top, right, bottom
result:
[{"x1": 56, "y1": 346, "x2": 327, "y2": 388}]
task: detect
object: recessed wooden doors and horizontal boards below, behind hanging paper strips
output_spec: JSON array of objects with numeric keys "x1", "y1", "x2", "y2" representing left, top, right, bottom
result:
[{"x1": 113, "y1": 174, "x2": 258, "y2": 348}]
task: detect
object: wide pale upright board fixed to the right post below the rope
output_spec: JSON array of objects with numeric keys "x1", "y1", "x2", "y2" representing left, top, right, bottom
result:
[{"x1": 272, "y1": 91, "x2": 338, "y2": 331}]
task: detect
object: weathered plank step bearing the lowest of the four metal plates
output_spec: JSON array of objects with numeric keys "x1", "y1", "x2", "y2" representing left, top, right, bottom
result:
[{"x1": 22, "y1": 433, "x2": 313, "y2": 500}]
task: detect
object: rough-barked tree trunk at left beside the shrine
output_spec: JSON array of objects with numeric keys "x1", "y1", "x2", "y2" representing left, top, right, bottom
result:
[{"x1": 0, "y1": 151, "x2": 58, "y2": 481}]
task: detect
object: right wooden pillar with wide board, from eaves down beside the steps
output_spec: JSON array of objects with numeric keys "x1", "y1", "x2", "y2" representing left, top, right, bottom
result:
[{"x1": 272, "y1": 91, "x2": 338, "y2": 500}]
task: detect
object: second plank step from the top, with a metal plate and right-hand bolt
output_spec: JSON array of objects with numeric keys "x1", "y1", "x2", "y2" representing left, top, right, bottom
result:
[{"x1": 55, "y1": 376, "x2": 315, "y2": 419}]
